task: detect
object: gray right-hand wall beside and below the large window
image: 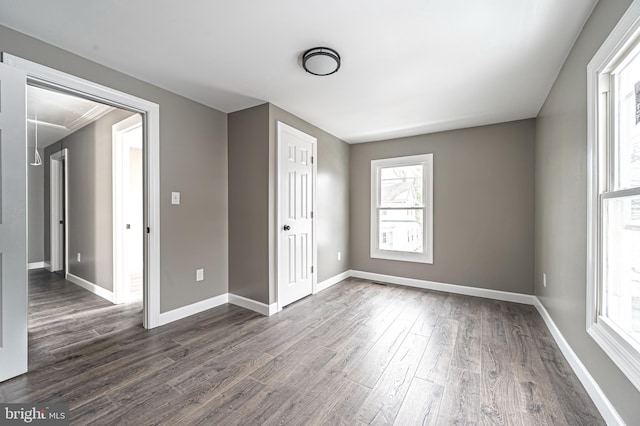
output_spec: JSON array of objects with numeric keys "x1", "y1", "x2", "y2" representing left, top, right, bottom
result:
[{"x1": 535, "y1": 0, "x2": 640, "y2": 424}]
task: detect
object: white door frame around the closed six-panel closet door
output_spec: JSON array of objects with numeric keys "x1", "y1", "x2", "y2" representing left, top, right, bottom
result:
[{"x1": 275, "y1": 121, "x2": 318, "y2": 312}]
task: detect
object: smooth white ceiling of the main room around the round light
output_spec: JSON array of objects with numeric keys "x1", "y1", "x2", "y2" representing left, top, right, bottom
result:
[{"x1": 0, "y1": 0, "x2": 597, "y2": 142}]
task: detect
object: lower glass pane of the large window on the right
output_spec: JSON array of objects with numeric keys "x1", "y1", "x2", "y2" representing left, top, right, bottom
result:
[{"x1": 602, "y1": 196, "x2": 640, "y2": 343}]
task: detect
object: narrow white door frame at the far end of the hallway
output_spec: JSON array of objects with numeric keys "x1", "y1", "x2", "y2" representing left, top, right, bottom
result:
[{"x1": 49, "y1": 148, "x2": 69, "y2": 279}]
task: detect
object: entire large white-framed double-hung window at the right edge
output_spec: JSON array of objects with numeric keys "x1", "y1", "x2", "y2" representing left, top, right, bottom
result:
[{"x1": 587, "y1": 4, "x2": 640, "y2": 389}]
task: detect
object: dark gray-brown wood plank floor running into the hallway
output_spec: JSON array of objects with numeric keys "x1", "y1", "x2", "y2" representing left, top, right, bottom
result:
[{"x1": 0, "y1": 270, "x2": 604, "y2": 425}]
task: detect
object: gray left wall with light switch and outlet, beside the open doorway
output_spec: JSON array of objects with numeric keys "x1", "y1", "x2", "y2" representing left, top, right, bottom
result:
[{"x1": 0, "y1": 26, "x2": 228, "y2": 312}]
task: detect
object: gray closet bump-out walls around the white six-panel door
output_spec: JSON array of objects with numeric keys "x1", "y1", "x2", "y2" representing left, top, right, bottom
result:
[{"x1": 229, "y1": 104, "x2": 349, "y2": 304}]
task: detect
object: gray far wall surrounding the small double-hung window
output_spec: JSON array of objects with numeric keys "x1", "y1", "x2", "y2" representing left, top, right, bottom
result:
[{"x1": 350, "y1": 120, "x2": 535, "y2": 294}]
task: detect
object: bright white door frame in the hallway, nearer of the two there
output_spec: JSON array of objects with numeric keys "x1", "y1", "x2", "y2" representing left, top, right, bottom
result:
[{"x1": 111, "y1": 114, "x2": 144, "y2": 304}]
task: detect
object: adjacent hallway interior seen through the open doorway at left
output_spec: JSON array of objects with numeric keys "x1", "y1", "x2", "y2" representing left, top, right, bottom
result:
[{"x1": 27, "y1": 85, "x2": 144, "y2": 346}]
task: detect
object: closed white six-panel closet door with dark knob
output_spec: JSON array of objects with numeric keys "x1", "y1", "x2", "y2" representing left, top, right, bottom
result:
[{"x1": 278, "y1": 122, "x2": 316, "y2": 308}]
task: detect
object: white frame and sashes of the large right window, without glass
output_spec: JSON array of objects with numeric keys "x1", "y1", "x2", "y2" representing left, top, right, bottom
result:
[{"x1": 586, "y1": 2, "x2": 640, "y2": 390}]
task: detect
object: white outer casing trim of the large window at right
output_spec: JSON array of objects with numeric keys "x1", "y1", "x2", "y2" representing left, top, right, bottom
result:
[{"x1": 587, "y1": 1, "x2": 640, "y2": 390}]
